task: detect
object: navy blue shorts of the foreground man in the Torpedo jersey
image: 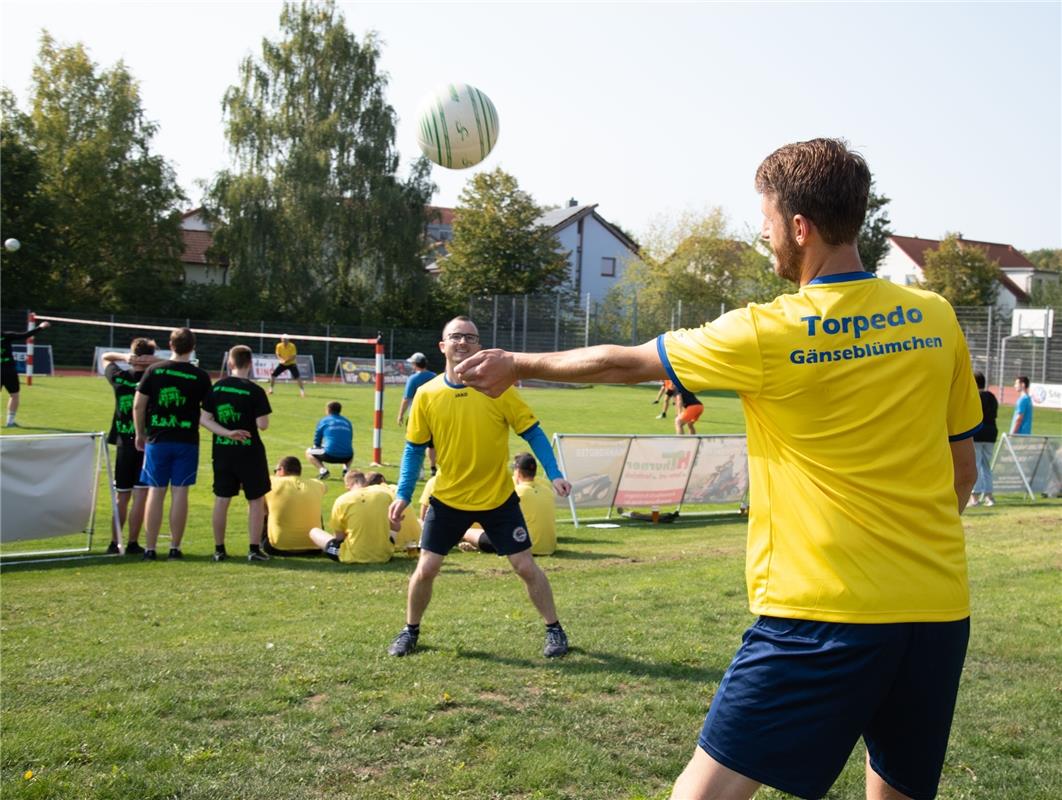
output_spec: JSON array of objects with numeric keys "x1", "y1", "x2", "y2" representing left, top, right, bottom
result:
[{"x1": 699, "y1": 616, "x2": 970, "y2": 800}]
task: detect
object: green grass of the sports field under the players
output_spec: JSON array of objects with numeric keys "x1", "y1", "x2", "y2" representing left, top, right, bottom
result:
[{"x1": 0, "y1": 378, "x2": 1062, "y2": 800}]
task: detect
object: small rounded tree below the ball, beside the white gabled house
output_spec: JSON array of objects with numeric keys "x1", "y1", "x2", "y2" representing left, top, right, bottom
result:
[{"x1": 441, "y1": 168, "x2": 568, "y2": 299}]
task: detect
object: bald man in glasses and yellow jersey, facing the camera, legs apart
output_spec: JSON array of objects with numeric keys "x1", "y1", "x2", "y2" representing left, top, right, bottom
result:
[{"x1": 388, "y1": 317, "x2": 571, "y2": 658}]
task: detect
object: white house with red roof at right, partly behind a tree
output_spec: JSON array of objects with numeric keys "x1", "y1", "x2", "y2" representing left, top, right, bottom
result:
[{"x1": 877, "y1": 235, "x2": 1062, "y2": 309}]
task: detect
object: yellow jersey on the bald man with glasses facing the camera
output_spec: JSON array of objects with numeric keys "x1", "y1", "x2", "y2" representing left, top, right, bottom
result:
[{"x1": 406, "y1": 373, "x2": 539, "y2": 511}]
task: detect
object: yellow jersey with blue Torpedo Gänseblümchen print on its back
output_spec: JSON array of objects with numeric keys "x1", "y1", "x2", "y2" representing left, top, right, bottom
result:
[{"x1": 657, "y1": 272, "x2": 981, "y2": 623}]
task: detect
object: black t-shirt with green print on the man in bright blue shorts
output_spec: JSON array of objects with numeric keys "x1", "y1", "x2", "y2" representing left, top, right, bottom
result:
[{"x1": 137, "y1": 361, "x2": 210, "y2": 444}]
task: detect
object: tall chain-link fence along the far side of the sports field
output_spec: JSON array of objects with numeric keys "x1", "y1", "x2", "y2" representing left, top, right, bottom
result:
[{"x1": 0, "y1": 294, "x2": 1062, "y2": 387}]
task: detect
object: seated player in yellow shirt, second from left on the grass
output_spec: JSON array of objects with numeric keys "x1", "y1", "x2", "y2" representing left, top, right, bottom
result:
[{"x1": 310, "y1": 470, "x2": 394, "y2": 564}]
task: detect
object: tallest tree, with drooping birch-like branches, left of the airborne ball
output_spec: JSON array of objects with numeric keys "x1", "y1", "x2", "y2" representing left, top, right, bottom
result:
[{"x1": 206, "y1": 0, "x2": 434, "y2": 323}]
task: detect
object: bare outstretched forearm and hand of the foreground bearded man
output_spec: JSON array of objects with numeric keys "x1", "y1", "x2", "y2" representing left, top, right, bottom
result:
[{"x1": 455, "y1": 339, "x2": 667, "y2": 397}]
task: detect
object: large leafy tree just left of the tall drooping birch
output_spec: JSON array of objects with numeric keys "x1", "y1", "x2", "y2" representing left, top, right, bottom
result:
[{"x1": 4, "y1": 37, "x2": 184, "y2": 311}]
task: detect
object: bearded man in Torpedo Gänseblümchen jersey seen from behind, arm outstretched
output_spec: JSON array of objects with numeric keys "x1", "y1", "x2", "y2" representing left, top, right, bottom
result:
[{"x1": 457, "y1": 139, "x2": 981, "y2": 799}]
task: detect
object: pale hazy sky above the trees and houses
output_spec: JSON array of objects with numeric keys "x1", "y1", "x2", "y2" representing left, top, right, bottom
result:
[{"x1": 0, "y1": 0, "x2": 1062, "y2": 250}]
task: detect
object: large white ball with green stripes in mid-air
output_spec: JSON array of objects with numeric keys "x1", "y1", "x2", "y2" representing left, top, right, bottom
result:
[{"x1": 416, "y1": 83, "x2": 498, "y2": 169}]
